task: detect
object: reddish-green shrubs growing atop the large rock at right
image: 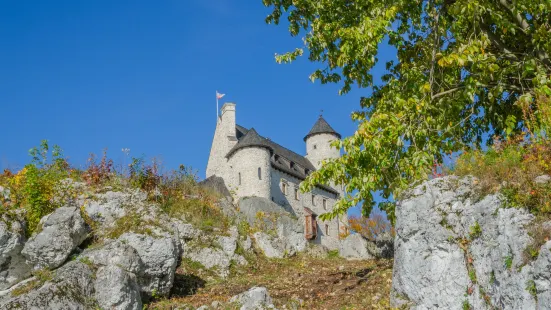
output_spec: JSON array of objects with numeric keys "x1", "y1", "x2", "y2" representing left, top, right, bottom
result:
[{"x1": 454, "y1": 137, "x2": 551, "y2": 216}]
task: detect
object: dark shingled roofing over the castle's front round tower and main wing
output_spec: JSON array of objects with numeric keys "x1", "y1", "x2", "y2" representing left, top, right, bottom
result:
[{"x1": 226, "y1": 121, "x2": 340, "y2": 195}]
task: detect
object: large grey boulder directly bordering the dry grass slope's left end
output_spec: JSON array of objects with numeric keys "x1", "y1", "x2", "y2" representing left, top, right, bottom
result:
[{"x1": 119, "y1": 230, "x2": 180, "y2": 296}]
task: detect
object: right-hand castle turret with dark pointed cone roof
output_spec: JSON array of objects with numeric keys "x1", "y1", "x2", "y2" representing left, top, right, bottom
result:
[{"x1": 304, "y1": 115, "x2": 341, "y2": 169}]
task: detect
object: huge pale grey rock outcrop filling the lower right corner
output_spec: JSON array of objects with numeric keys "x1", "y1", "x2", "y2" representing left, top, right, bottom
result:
[{"x1": 391, "y1": 176, "x2": 551, "y2": 309}]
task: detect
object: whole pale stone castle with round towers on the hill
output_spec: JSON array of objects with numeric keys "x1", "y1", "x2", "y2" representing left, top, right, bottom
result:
[{"x1": 206, "y1": 103, "x2": 347, "y2": 245}]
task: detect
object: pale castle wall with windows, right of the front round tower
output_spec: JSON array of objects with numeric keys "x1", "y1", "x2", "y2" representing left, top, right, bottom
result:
[{"x1": 271, "y1": 168, "x2": 343, "y2": 243}]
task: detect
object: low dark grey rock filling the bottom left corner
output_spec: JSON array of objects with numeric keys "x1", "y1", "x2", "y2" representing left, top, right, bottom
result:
[{"x1": 0, "y1": 261, "x2": 96, "y2": 310}]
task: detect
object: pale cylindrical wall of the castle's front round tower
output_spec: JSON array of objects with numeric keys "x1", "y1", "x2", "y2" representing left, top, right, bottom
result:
[{"x1": 226, "y1": 147, "x2": 271, "y2": 199}]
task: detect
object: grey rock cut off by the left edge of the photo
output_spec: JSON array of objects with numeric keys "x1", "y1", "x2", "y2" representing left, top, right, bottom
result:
[{"x1": 0, "y1": 220, "x2": 31, "y2": 291}]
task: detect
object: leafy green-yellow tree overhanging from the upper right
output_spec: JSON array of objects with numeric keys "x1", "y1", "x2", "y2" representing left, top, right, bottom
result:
[{"x1": 263, "y1": 0, "x2": 551, "y2": 223}]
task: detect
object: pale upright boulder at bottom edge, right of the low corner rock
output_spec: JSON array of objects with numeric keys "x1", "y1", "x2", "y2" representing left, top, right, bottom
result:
[{"x1": 94, "y1": 265, "x2": 142, "y2": 310}]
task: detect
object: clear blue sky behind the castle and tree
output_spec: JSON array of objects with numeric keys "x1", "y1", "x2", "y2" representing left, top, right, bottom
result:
[{"x1": 0, "y1": 0, "x2": 392, "y2": 216}]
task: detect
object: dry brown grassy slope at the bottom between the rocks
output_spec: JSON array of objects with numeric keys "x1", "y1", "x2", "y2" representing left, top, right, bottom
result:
[{"x1": 148, "y1": 255, "x2": 392, "y2": 310}]
